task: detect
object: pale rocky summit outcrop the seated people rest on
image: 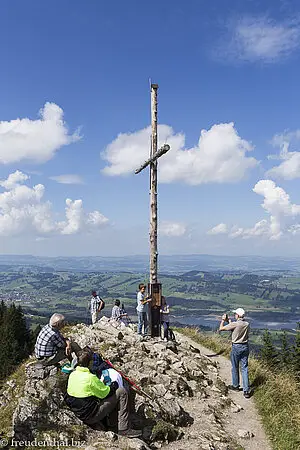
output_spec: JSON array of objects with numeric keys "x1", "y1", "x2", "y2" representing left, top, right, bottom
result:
[{"x1": 0, "y1": 317, "x2": 241, "y2": 450}]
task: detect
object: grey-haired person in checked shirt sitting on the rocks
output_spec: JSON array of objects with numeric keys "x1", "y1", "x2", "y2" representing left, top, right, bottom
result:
[{"x1": 35, "y1": 313, "x2": 81, "y2": 366}]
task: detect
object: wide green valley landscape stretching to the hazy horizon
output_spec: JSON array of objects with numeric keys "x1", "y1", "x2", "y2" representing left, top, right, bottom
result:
[{"x1": 0, "y1": 255, "x2": 300, "y2": 342}]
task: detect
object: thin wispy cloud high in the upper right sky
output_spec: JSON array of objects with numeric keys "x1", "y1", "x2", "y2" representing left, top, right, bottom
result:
[{"x1": 217, "y1": 16, "x2": 300, "y2": 63}]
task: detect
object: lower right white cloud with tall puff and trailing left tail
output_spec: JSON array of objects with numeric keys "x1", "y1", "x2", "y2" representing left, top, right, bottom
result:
[{"x1": 208, "y1": 180, "x2": 300, "y2": 241}]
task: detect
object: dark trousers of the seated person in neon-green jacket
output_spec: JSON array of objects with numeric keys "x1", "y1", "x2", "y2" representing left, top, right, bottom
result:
[{"x1": 84, "y1": 388, "x2": 129, "y2": 431}]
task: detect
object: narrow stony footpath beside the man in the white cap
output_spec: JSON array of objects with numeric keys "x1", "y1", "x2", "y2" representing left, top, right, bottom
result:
[{"x1": 176, "y1": 333, "x2": 271, "y2": 450}]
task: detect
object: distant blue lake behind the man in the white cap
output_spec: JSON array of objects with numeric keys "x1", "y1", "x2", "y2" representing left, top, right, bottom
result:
[{"x1": 175, "y1": 314, "x2": 300, "y2": 330}]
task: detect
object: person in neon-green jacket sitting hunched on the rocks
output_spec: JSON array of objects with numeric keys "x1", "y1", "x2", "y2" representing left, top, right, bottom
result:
[{"x1": 65, "y1": 349, "x2": 141, "y2": 438}]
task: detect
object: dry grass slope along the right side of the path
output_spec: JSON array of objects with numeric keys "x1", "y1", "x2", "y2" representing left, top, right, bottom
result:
[{"x1": 176, "y1": 328, "x2": 300, "y2": 450}]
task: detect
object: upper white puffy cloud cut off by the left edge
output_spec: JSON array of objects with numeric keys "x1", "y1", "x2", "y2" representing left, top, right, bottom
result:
[{"x1": 0, "y1": 103, "x2": 80, "y2": 164}]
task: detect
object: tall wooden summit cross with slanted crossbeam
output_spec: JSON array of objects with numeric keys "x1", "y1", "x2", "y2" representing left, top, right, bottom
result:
[{"x1": 135, "y1": 84, "x2": 170, "y2": 337}]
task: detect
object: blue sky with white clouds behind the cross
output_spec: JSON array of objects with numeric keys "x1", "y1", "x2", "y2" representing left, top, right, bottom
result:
[{"x1": 0, "y1": 0, "x2": 300, "y2": 256}]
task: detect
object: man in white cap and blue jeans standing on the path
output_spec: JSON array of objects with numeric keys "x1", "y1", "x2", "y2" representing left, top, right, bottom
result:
[{"x1": 219, "y1": 308, "x2": 250, "y2": 398}]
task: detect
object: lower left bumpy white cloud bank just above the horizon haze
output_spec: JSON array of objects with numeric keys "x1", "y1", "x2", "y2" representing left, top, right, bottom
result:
[{"x1": 0, "y1": 171, "x2": 108, "y2": 236}]
